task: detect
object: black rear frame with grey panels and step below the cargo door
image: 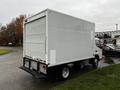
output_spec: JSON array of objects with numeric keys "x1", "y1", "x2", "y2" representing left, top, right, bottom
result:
[{"x1": 20, "y1": 57, "x2": 47, "y2": 78}]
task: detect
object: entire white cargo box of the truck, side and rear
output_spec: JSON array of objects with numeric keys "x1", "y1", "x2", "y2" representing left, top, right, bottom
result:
[{"x1": 24, "y1": 9, "x2": 95, "y2": 67}]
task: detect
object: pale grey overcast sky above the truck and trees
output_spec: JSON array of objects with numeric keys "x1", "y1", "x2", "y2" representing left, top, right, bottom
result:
[{"x1": 0, "y1": 0, "x2": 120, "y2": 32}]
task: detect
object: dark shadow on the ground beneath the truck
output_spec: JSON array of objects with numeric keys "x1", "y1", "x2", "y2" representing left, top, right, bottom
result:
[{"x1": 21, "y1": 66, "x2": 93, "y2": 90}]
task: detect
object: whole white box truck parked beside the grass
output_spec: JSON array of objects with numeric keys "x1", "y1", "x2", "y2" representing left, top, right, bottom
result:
[{"x1": 21, "y1": 9, "x2": 100, "y2": 79}]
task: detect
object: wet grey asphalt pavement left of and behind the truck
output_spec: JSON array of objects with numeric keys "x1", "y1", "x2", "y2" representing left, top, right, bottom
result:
[{"x1": 0, "y1": 47, "x2": 61, "y2": 90}]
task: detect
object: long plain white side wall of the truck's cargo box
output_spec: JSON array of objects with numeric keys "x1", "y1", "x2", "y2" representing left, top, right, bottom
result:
[{"x1": 48, "y1": 10, "x2": 95, "y2": 66}]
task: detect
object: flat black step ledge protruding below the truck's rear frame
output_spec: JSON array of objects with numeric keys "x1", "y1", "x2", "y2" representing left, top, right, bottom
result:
[{"x1": 19, "y1": 66, "x2": 47, "y2": 79}]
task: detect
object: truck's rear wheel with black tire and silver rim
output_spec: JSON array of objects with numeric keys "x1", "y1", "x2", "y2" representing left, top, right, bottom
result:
[{"x1": 60, "y1": 66, "x2": 70, "y2": 80}]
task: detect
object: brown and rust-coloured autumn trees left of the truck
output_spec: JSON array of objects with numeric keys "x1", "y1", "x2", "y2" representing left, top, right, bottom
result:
[{"x1": 0, "y1": 15, "x2": 25, "y2": 45}]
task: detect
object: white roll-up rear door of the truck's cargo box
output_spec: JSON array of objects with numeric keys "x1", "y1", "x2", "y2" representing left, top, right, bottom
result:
[{"x1": 24, "y1": 17, "x2": 46, "y2": 60}]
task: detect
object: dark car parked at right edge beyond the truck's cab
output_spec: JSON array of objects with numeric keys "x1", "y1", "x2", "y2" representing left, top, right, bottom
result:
[{"x1": 103, "y1": 44, "x2": 120, "y2": 57}]
